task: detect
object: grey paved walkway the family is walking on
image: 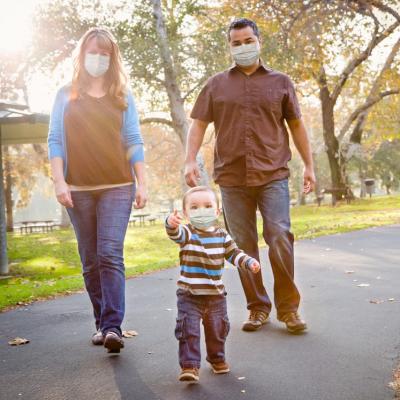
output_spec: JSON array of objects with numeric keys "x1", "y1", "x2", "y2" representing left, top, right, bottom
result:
[{"x1": 0, "y1": 226, "x2": 400, "y2": 400}]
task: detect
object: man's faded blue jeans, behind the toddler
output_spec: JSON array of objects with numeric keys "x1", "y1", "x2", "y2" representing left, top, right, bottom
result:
[{"x1": 220, "y1": 179, "x2": 300, "y2": 319}]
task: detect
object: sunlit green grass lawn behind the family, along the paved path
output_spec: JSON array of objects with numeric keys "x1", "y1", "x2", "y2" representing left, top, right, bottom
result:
[{"x1": 0, "y1": 195, "x2": 400, "y2": 310}]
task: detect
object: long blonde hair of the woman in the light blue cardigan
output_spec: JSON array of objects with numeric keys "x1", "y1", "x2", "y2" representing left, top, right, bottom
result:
[{"x1": 71, "y1": 28, "x2": 128, "y2": 110}]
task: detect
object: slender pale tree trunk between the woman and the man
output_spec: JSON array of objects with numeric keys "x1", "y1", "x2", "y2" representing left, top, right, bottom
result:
[{"x1": 152, "y1": 0, "x2": 208, "y2": 185}]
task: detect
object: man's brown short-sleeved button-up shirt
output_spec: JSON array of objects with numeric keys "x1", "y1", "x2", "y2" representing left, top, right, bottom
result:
[{"x1": 190, "y1": 65, "x2": 301, "y2": 186}]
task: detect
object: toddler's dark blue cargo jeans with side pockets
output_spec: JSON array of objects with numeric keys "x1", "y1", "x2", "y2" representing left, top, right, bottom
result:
[{"x1": 175, "y1": 289, "x2": 229, "y2": 368}]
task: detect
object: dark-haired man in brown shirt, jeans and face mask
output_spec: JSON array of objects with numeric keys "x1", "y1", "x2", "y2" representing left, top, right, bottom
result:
[{"x1": 185, "y1": 18, "x2": 315, "y2": 333}]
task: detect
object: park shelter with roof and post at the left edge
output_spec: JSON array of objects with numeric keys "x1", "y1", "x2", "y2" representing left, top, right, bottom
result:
[{"x1": 0, "y1": 101, "x2": 49, "y2": 275}]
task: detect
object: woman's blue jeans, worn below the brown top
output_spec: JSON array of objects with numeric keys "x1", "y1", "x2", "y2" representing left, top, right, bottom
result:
[{"x1": 67, "y1": 185, "x2": 135, "y2": 335}]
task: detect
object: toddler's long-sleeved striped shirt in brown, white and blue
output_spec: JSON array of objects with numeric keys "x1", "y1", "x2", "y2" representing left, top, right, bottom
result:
[{"x1": 165, "y1": 222, "x2": 254, "y2": 295}]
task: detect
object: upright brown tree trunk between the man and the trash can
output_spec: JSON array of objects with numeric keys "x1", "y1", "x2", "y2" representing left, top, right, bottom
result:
[{"x1": 320, "y1": 87, "x2": 345, "y2": 200}]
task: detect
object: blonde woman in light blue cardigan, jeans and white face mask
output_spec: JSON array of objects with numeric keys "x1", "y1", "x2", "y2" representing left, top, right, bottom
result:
[{"x1": 48, "y1": 28, "x2": 147, "y2": 353}]
